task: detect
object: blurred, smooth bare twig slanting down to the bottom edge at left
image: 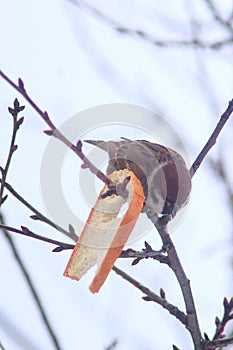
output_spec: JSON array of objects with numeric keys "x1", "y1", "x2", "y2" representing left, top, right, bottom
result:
[{"x1": 0, "y1": 214, "x2": 62, "y2": 350}]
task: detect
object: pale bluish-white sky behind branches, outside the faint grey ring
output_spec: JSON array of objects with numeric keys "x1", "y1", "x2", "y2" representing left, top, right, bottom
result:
[{"x1": 0, "y1": 0, "x2": 233, "y2": 350}]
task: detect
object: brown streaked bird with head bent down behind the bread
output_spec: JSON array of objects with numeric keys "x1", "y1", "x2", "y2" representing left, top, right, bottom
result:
[{"x1": 85, "y1": 138, "x2": 191, "y2": 217}]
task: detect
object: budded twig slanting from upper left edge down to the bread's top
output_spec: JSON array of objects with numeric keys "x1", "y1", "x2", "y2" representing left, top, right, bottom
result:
[{"x1": 0, "y1": 70, "x2": 115, "y2": 188}]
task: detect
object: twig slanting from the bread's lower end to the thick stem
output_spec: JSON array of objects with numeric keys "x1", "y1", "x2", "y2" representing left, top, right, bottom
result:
[{"x1": 112, "y1": 266, "x2": 187, "y2": 326}]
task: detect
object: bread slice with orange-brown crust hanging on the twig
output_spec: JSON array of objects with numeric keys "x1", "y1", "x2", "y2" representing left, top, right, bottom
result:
[{"x1": 64, "y1": 169, "x2": 144, "y2": 293}]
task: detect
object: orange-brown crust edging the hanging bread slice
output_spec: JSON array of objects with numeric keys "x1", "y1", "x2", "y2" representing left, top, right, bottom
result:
[{"x1": 64, "y1": 169, "x2": 144, "y2": 293}]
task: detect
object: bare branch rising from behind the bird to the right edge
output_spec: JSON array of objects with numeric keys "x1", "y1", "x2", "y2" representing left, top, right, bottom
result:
[{"x1": 190, "y1": 100, "x2": 233, "y2": 177}]
